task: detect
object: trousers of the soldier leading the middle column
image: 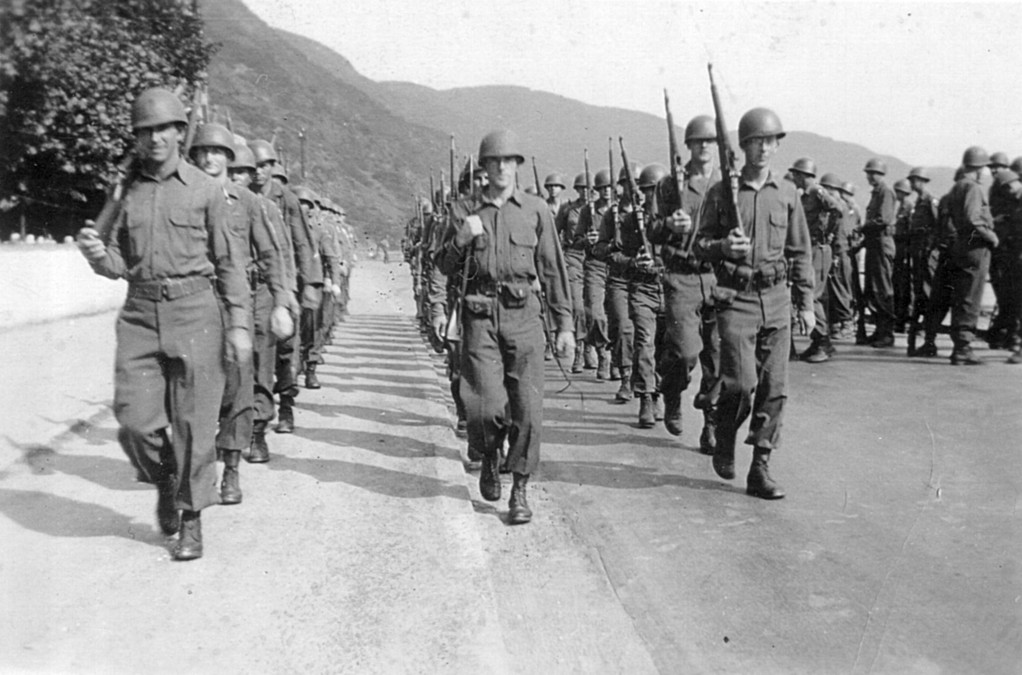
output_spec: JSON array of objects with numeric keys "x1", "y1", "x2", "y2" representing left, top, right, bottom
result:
[{"x1": 460, "y1": 294, "x2": 544, "y2": 475}]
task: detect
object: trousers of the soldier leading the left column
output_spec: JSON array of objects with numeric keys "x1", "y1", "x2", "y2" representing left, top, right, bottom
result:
[{"x1": 113, "y1": 286, "x2": 224, "y2": 511}]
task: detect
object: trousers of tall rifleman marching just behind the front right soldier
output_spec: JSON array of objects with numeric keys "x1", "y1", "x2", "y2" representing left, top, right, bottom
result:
[{"x1": 657, "y1": 272, "x2": 721, "y2": 410}]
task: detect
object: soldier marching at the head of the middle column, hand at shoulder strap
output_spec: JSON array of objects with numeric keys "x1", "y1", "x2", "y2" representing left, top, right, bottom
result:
[{"x1": 437, "y1": 131, "x2": 574, "y2": 524}]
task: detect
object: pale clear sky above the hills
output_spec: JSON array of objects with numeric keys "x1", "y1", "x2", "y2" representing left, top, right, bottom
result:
[{"x1": 244, "y1": 0, "x2": 1022, "y2": 167}]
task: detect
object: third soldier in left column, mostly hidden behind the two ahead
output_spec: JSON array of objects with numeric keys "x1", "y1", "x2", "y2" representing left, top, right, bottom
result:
[{"x1": 228, "y1": 142, "x2": 299, "y2": 464}]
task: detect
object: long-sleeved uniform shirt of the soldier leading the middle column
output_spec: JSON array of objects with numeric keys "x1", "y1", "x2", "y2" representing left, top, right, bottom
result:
[{"x1": 436, "y1": 188, "x2": 574, "y2": 332}]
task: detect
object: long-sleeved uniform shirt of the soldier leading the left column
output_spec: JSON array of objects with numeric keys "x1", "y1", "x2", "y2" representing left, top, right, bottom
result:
[{"x1": 91, "y1": 159, "x2": 249, "y2": 328}]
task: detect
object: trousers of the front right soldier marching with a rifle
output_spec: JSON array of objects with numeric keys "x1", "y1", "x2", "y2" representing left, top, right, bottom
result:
[{"x1": 716, "y1": 283, "x2": 791, "y2": 453}]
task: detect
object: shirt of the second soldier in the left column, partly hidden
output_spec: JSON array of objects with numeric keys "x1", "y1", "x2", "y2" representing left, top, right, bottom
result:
[{"x1": 224, "y1": 183, "x2": 290, "y2": 307}]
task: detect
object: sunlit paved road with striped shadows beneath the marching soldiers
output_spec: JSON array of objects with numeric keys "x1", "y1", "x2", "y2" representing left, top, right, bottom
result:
[{"x1": 0, "y1": 262, "x2": 1022, "y2": 673}]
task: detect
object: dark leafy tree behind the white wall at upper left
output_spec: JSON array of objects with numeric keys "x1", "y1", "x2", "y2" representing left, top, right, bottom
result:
[{"x1": 0, "y1": 0, "x2": 216, "y2": 227}]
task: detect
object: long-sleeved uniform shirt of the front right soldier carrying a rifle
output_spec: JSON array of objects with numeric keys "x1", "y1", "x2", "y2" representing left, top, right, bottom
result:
[{"x1": 695, "y1": 171, "x2": 814, "y2": 311}]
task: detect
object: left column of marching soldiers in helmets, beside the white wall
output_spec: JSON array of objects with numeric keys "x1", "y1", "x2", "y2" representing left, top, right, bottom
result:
[{"x1": 79, "y1": 88, "x2": 352, "y2": 560}]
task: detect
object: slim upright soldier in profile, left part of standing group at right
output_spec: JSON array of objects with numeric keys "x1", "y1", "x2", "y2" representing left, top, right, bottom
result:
[{"x1": 860, "y1": 158, "x2": 896, "y2": 349}]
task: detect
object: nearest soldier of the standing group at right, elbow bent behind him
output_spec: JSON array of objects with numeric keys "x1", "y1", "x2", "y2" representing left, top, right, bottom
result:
[{"x1": 946, "y1": 145, "x2": 997, "y2": 365}]
